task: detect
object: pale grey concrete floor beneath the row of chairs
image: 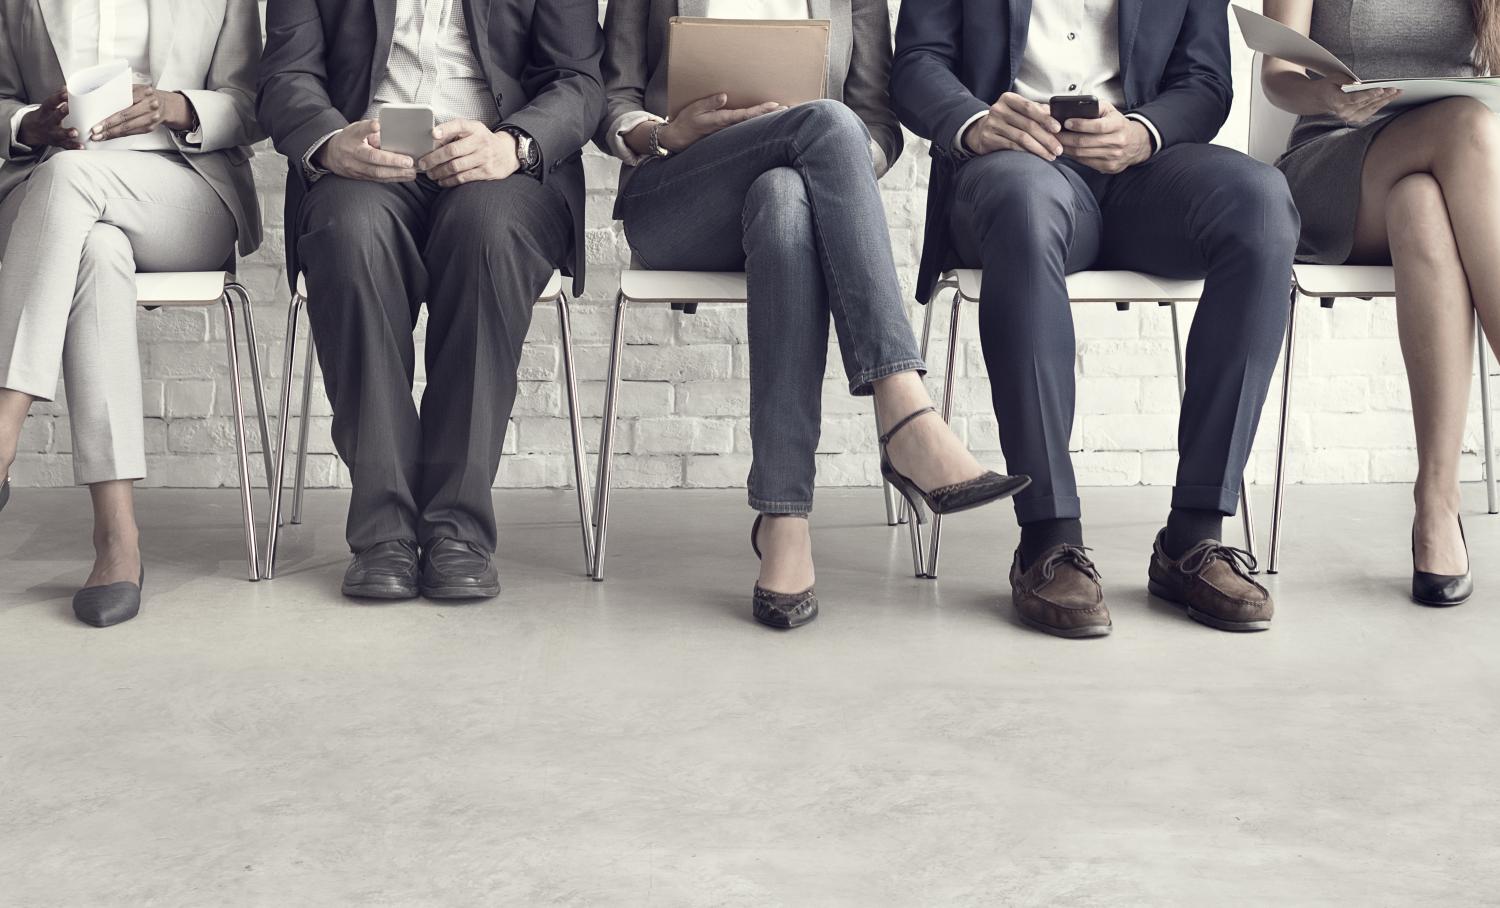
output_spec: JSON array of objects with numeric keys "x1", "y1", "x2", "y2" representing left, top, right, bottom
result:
[{"x1": 0, "y1": 488, "x2": 1500, "y2": 908}]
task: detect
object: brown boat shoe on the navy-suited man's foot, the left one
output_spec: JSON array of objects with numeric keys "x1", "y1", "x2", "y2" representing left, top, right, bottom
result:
[{"x1": 1011, "y1": 545, "x2": 1113, "y2": 636}]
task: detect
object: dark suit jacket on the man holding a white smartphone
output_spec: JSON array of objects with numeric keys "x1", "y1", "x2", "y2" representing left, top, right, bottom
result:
[{"x1": 255, "y1": 0, "x2": 605, "y2": 293}]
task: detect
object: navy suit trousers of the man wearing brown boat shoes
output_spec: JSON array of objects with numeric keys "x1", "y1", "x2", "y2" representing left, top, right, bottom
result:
[{"x1": 951, "y1": 144, "x2": 1299, "y2": 525}]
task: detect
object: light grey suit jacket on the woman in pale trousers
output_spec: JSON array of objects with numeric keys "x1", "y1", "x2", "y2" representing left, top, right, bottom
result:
[{"x1": 0, "y1": 0, "x2": 264, "y2": 255}]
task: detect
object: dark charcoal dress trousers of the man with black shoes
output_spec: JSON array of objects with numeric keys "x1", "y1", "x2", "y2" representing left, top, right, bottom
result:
[{"x1": 297, "y1": 174, "x2": 573, "y2": 552}]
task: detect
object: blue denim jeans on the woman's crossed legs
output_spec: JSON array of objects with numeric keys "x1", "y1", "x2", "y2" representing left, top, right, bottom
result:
[{"x1": 618, "y1": 101, "x2": 926, "y2": 515}]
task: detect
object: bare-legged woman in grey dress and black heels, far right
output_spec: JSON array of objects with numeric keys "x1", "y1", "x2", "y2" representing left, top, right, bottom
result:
[{"x1": 1263, "y1": 0, "x2": 1500, "y2": 605}]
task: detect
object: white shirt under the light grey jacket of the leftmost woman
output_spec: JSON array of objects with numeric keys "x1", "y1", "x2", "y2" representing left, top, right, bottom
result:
[{"x1": 11, "y1": 0, "x2": 181, "y2": 153}]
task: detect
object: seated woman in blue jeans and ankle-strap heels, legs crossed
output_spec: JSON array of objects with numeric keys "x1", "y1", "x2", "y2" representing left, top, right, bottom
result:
[{"x1": 596, "y1": 0, "x2": 1026, "y2": 627}]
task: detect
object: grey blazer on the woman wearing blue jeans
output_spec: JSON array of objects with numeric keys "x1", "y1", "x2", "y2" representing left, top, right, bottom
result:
[{"x1": 594, "y1": 0, "x2": 903, "y2": 189}]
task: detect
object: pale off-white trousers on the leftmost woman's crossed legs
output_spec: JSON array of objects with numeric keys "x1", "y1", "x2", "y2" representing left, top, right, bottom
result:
[{"x1": 0, "y1": 150, "x2": 236, "y2": 485}]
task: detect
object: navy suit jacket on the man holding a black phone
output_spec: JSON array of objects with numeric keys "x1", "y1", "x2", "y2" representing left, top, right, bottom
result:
[{"x1": 891, "y1": 0, "x2": 1233, "y2": 303}]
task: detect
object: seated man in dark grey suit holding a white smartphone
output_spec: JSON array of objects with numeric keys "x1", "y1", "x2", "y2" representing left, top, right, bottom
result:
[{"x1": 257, "y1": 0, "x2": 603, "y2": 599}]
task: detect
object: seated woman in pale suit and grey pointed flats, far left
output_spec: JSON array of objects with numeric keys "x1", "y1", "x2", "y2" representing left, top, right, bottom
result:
[{"x1": 0, "y1": 0, "x2": 261, "y2": 627}]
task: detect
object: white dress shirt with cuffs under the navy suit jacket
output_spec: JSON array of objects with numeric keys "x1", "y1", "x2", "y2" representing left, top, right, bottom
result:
[{"x1": 954, "y1": 0, "x2": 1161, "y2": 155}]
